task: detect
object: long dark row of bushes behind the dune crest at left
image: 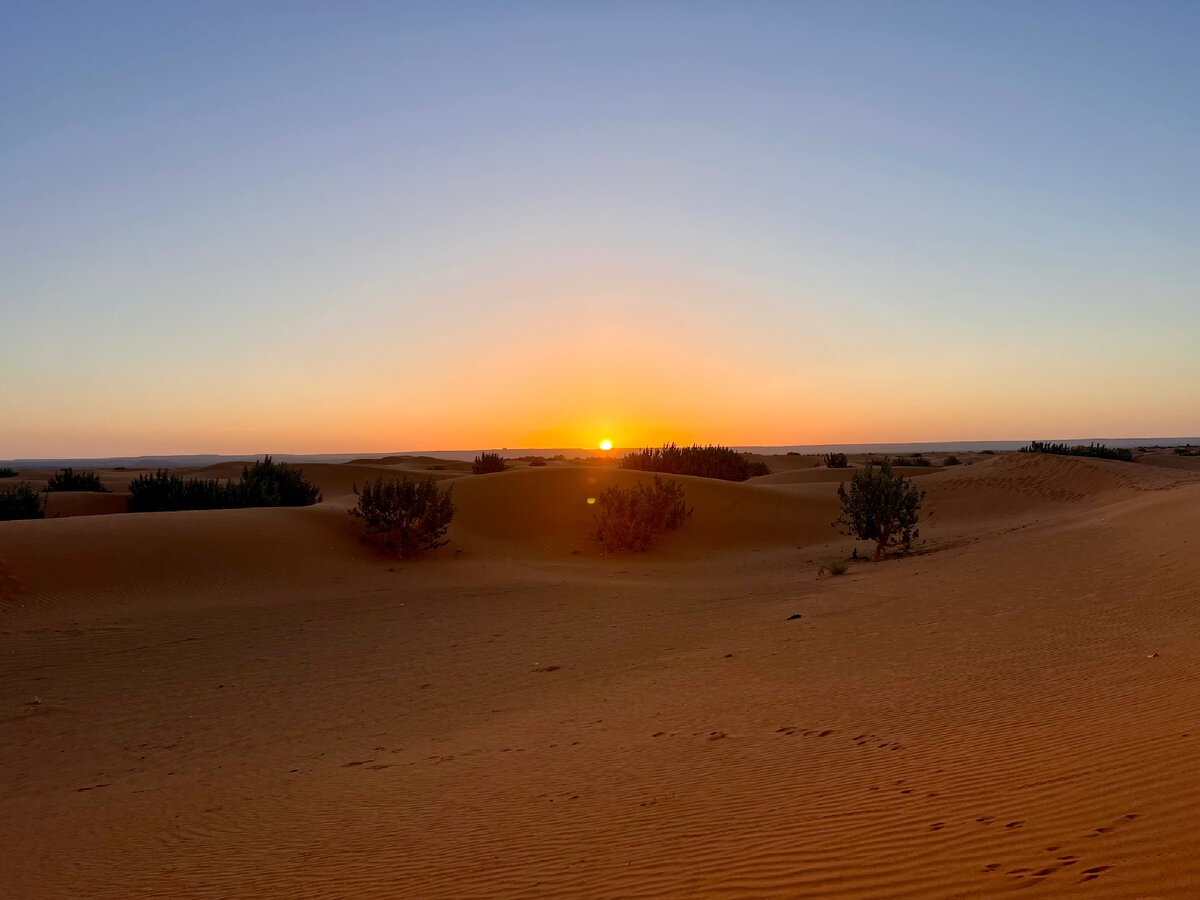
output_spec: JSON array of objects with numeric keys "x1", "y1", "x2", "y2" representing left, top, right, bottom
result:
[{"x1": 130, "y1": 456, "x2": 320, "y2": 512}]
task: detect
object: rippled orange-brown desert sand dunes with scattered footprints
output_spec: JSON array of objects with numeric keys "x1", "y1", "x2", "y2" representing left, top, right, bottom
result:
[{"x1": 0, "y1": 454, "x2": 1200, "y2": 898}]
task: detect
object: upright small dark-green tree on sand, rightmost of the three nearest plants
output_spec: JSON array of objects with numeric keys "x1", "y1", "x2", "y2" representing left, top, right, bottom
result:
[{"x1": 834, "y1": 461, "x2": 925, "y2": 559}]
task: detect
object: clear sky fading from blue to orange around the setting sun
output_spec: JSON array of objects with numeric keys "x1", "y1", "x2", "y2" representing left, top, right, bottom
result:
[{"x1": 0, "y1": 0, "x2": 1200, "y2": 458}]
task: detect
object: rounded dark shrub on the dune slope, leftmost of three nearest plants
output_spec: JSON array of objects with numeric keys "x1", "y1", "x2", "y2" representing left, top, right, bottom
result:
[{"x1": 349, "y1": 475, "x2": 455, "y2": 558}]
